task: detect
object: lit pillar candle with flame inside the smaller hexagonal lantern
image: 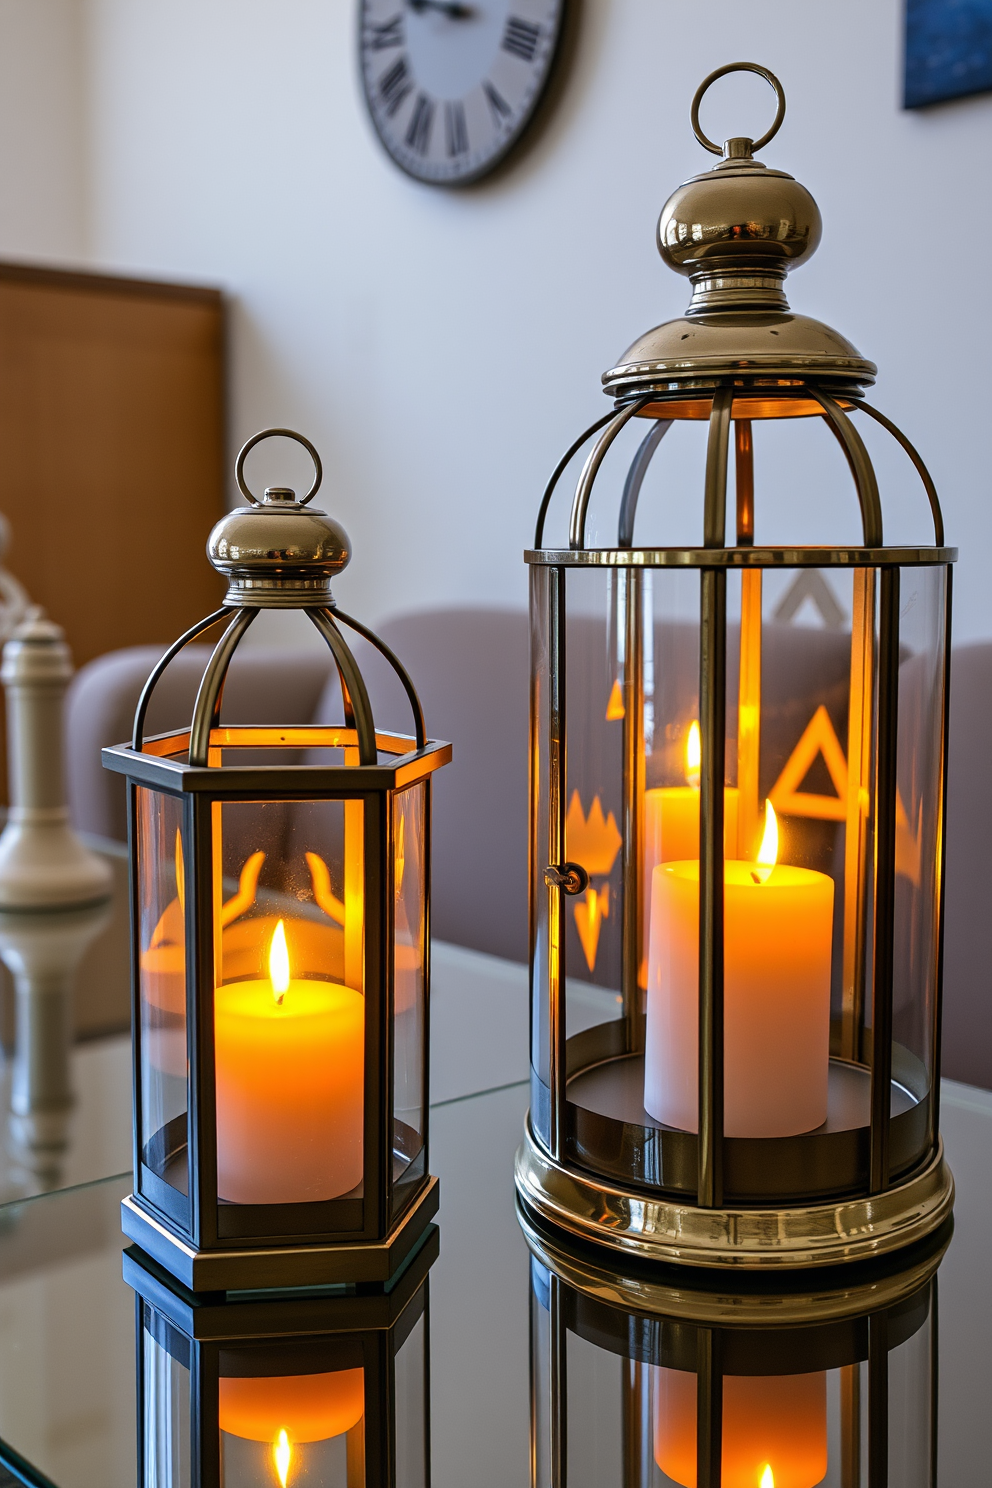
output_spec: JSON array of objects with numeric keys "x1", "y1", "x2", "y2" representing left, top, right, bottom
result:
[{"x1": 214, "y1": 921, "x2": 364, "y2": 1204}]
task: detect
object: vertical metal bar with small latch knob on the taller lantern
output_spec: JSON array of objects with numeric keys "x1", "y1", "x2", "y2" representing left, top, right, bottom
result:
[{"x1": 547, "y1": 568, "x2": 567, "y2": 1159}]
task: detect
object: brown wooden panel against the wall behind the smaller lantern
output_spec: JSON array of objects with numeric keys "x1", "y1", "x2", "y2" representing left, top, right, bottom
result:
[{"x1": 0, "y1": 263, "x2": 225, "y2": 799}]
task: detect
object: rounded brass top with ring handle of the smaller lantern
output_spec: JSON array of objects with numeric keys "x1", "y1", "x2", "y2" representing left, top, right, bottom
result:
[{"x1": 207, "y1": 429, "x2": 351, "y2": 609}]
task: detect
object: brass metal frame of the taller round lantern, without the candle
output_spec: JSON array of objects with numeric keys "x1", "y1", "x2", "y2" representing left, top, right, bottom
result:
[{"x1": 516, "y1": 64, "x2": 956, "y2": 1268}]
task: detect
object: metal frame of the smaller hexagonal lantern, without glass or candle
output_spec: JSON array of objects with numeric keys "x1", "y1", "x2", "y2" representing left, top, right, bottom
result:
[{"x1": 103, "y1": 429, "x2": 451, "y2": 1292}]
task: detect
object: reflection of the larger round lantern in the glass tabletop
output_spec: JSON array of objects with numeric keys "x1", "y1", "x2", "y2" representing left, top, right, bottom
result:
[{"x1": 522, "y1": 1214, "x2": 950, "y2": 1488}]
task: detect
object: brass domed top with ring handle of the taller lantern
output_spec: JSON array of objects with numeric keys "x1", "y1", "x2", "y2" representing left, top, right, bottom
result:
[{"x1": 602, "y1": 62, "x2": 876, "y2": 399}]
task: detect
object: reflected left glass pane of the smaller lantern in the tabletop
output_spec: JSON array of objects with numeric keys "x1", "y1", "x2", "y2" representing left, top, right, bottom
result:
[{"x1": 141, "y1": 1306, "x2": 190, "y2": 1488}]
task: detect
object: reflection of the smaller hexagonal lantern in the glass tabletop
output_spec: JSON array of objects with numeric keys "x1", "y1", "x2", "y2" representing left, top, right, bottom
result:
[{"x1": 123, "y1": 1228, "x2": 437, "y2": 1488}]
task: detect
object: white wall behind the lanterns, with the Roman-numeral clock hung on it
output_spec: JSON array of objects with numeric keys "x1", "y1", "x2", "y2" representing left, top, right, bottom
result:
[{"x1": 5, "y1": 0, "x2": 992, "y2": 637}]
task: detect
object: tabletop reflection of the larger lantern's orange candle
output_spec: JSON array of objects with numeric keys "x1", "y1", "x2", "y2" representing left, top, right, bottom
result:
[{"x1": 653, "y1": 1369, "x2": 827, "y2": 1488}]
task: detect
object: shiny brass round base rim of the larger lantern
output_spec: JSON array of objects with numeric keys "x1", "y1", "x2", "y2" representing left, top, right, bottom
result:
[{"x1": 515, "y1": 1116, "x2": 955, "y2": 1272}]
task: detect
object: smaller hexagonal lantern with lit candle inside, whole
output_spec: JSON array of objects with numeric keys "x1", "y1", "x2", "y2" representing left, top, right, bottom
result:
[{"x1": 104, "y1": 430, "x2": 451, "y2": 1290}]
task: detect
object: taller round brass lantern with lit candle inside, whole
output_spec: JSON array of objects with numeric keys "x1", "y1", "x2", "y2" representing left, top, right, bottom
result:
[{"x1": 518, "y1": 64, "x2": 956, "y2": 1266}]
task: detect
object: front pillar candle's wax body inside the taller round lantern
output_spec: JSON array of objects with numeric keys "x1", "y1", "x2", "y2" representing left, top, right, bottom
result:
[{"x1": 644, "y1": 809, "x2": 833, "y2": 1137}]
